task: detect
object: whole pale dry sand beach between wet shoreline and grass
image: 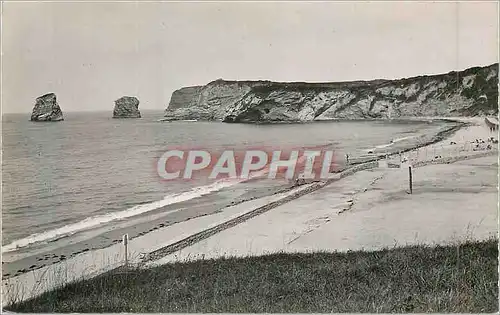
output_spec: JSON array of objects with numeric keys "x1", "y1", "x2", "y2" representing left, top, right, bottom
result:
[{"x1": 3, "y1": 119, "x2": 498, "y2": 301}]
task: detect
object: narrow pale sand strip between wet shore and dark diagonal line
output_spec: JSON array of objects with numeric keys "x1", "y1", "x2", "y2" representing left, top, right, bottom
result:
[{"x1": 2, "y1": 185, "x2": 318, "y2": 305}]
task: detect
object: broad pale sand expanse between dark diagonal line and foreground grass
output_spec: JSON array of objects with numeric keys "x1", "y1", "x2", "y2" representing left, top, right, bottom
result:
[{"x1": 146, "y1": 121, "x2": 498, "y2": 267}]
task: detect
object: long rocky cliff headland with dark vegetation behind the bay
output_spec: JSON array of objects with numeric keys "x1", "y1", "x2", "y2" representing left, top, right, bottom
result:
[{"x1": 165, "y1": 63, "x2": 498, "y2": 122}]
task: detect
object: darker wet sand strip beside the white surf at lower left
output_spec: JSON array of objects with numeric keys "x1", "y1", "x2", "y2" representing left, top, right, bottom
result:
[{"x1": 2, "y1": 181, "x2": 291, "y2": 279}]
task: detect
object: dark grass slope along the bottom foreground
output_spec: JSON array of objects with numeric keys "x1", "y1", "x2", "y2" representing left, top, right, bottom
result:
[{"x1": 8, "y1": 240, "x2": 498, "y2": 313}]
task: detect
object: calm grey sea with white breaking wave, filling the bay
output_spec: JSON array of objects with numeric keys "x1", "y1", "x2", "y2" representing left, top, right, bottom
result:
[{"x1": 2, "y1": 110, "x2": 448, "y2": 276}]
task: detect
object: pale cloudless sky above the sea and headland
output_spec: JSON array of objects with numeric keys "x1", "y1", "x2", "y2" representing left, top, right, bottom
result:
[{"x1": 2, "y1": 1, "x2": 498, "y2": 113}]
